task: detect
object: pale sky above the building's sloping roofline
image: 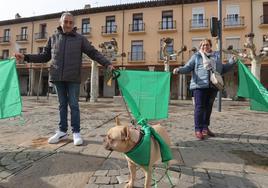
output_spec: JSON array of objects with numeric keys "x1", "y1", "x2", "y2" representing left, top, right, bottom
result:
[{"x1": 0, "y1": 0, "x2": 148, "y2": 21}]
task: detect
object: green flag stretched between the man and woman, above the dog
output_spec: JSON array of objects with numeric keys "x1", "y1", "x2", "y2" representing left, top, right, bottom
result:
[{"x1": 117, "y1": 70, "x2": 170, "y2": 121}]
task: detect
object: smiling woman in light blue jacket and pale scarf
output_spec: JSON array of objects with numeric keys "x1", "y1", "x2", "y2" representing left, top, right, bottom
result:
[{"x1": 173, "y1": 39, "x2": 235, "y2": 140}]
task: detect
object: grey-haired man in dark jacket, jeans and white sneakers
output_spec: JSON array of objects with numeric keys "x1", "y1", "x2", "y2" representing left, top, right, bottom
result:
[{"x1": 15, "y1": 12, "x2": 114, "y2": 146}]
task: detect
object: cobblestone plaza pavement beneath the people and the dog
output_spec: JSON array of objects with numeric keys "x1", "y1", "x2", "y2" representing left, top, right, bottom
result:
[{"x1": 0, "y1": 96, "x2": 268, "y2": 188}]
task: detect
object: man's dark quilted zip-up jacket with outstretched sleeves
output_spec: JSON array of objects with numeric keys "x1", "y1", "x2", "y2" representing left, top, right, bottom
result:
[{"x1": 24, "y1": 27, "x2": 111, "y2": 83}]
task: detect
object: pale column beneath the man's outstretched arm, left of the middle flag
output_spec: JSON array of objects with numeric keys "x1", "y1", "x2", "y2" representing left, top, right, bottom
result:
[{"x1": 89, "y1": 60, "x2": 99, "y2": 103}]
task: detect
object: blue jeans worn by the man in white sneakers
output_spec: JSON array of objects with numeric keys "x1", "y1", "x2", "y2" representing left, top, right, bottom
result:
[{"x1": 54, "y1": 82, "x2": 80, "y2": 133}]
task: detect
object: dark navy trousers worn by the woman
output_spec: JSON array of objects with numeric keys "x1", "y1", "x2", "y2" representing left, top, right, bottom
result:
[{"x1": 193, "y1": 88, "x2": 218, "y2": 131}]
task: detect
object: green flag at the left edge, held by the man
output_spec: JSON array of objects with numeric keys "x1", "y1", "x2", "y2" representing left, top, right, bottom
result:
[{"x1": 0, "y1": 59, "x2": 22, "y2": 119}]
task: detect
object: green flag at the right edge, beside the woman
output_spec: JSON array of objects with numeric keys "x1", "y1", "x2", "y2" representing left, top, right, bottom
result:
[{"x1": 237, "y1": 60, "x2": 268, "y2": 112}]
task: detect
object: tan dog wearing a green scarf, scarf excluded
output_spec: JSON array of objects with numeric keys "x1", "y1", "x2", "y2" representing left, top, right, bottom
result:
[{"x1": 104, "y1": 118, "x2": 170, "y2": 188}]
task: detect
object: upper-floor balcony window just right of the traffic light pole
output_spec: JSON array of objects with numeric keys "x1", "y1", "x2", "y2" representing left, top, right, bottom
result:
[{"x1": 224, "y1": 5, "x2": 241, "y2": 26}]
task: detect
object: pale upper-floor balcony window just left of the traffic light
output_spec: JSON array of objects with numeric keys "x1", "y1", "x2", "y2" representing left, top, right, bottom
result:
[{"x1": 191, "y1": 7, "x2": 205, "y2": 28}]
